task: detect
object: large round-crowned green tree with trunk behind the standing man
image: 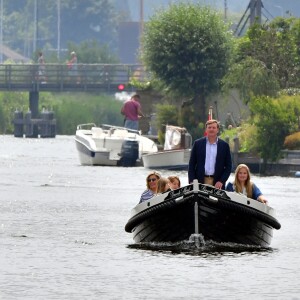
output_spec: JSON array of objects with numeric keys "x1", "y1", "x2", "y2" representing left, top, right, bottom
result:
[{"x1": 141, "y1": 3, "x2": 232, "y2": 127}]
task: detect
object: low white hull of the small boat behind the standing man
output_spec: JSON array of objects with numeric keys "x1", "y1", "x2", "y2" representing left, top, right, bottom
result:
[{"x1": 142, "y1": 149, "x2": 191, "y2": 170}]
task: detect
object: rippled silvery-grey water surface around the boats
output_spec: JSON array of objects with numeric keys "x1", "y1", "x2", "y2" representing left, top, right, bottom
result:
[{"x1": 0, "y1": 136, "x2": 300, "y2": 300}]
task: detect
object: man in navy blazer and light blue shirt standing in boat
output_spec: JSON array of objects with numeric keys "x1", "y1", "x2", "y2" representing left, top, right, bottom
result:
[{"x1": 188, "y1": 120, "x2": 232, "y2": 189}]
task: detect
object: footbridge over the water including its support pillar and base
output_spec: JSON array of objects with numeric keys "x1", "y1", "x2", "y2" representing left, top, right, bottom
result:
[{"x1": 0, "y1": 64, "x2": 145, "y2": 137}]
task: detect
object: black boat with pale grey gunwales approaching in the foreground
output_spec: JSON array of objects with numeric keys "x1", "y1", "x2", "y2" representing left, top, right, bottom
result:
[{"x1": 125, "y1": 180, "x2": 281, "y2": 247}]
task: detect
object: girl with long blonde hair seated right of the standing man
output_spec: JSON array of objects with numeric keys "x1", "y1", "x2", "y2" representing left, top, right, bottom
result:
[{"x1": 226, "y1": 164, "x2": 268, "y2": 204}]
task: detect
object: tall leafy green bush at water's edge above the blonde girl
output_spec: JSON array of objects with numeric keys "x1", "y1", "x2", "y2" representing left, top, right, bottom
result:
[{"x1": 250, "y1": 97, "x2": 296, "y2": 162}]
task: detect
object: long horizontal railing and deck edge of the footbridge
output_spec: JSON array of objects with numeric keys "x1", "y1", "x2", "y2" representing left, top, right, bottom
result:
[{"x1": 0, "y1": 64, "x2": 147, "y2": 92}]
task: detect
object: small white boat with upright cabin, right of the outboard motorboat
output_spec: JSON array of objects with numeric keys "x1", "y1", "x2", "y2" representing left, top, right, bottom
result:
[{"x1": 142, "y1": 125, "x2": 192, "y2": 170}]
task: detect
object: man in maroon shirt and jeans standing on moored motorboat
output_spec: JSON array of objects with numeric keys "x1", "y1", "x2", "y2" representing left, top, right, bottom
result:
[{"x1": 121, "y1": 94, "x2": 144, "y2": 130}]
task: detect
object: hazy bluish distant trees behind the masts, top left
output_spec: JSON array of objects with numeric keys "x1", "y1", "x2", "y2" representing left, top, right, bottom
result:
[{"x1": 3, "y1": 0, "x2": 123, "y2": 58}]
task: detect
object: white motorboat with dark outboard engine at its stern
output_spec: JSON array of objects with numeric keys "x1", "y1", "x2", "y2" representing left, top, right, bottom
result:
[{"x1": 75, "y1": 123, "x2": 158, "y2": 167}]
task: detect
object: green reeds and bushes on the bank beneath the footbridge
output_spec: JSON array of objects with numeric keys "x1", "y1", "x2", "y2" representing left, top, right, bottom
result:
[{"x1": 0, "y1": 92, "x2": 123, "y2": 135}]
